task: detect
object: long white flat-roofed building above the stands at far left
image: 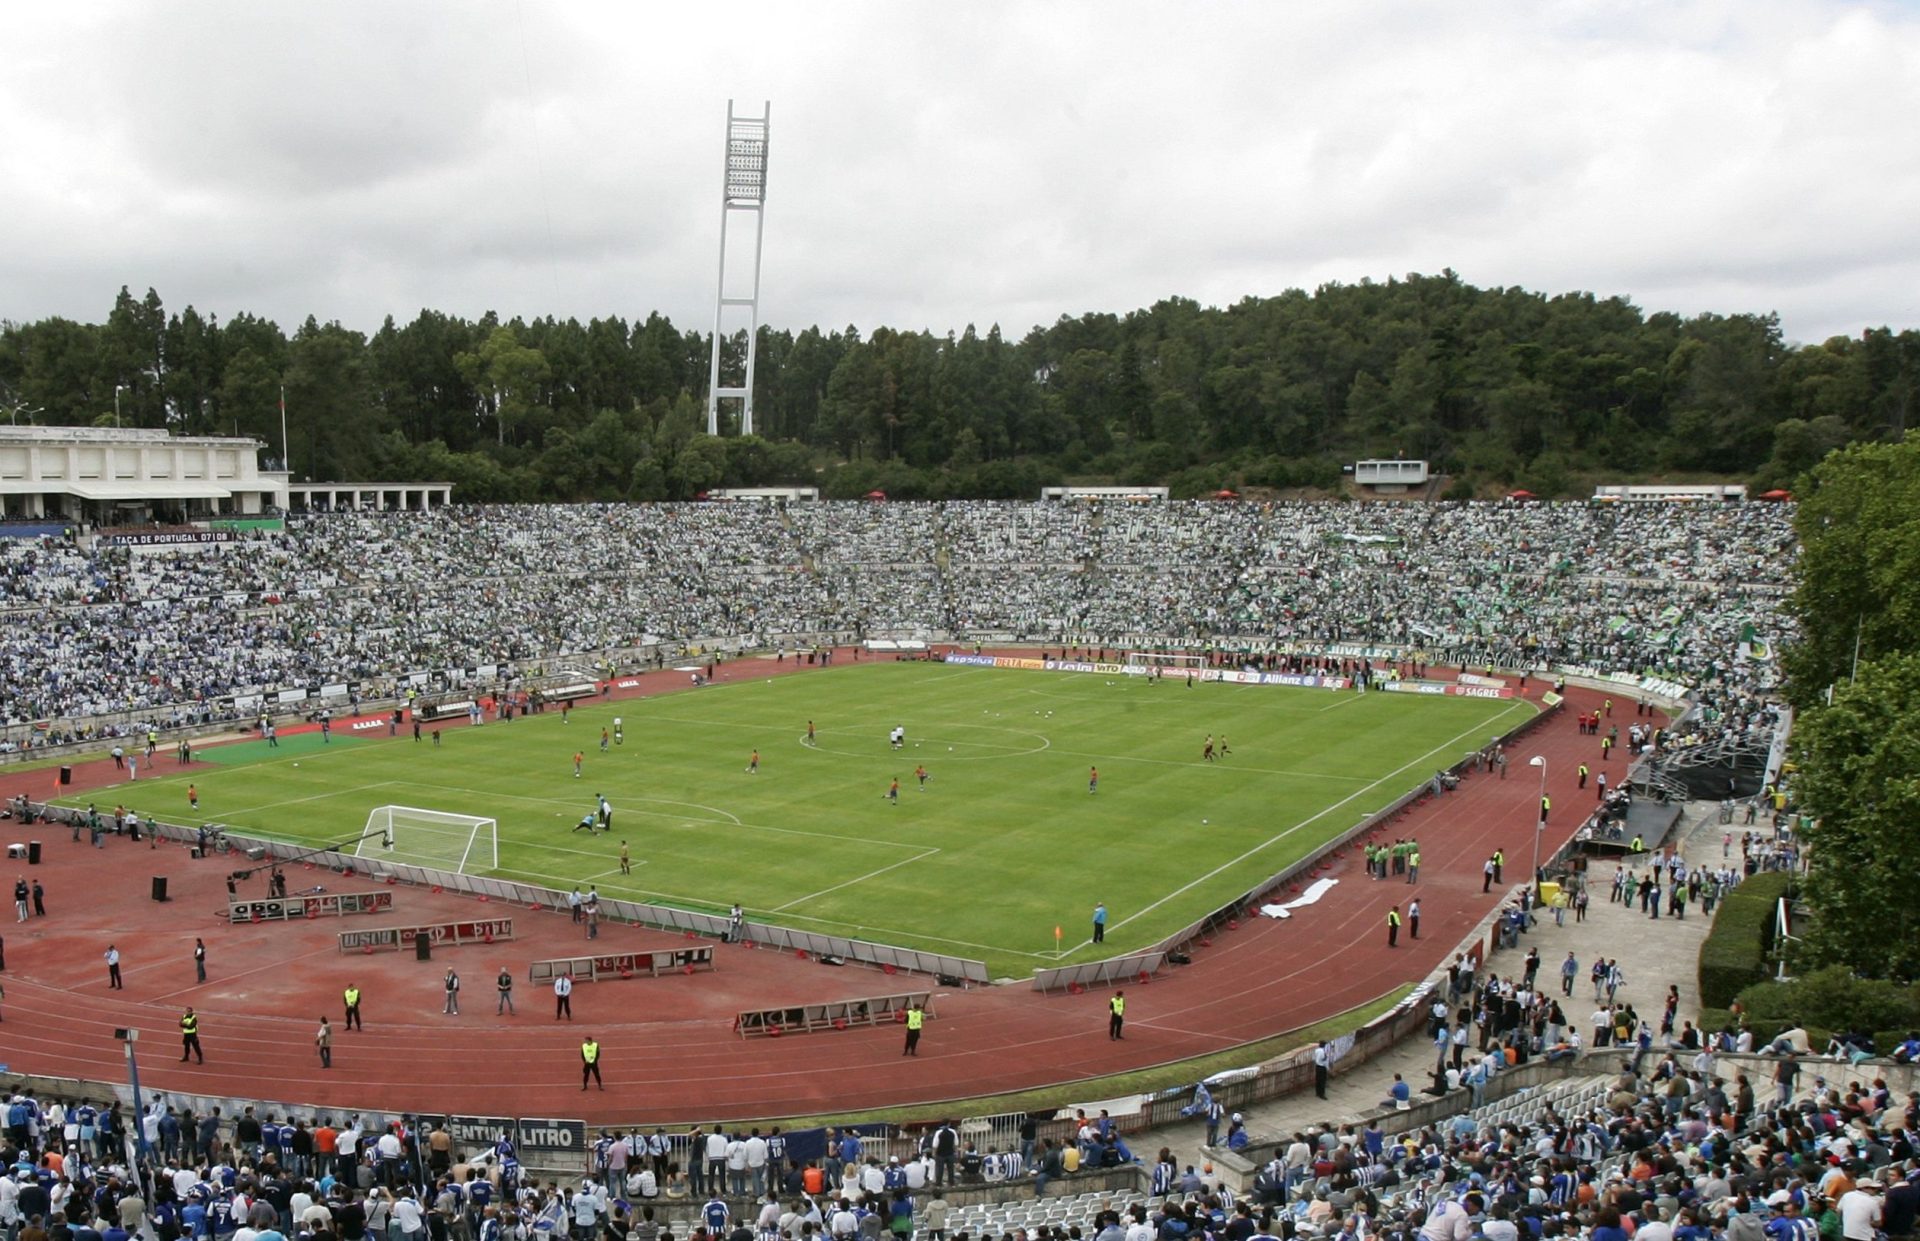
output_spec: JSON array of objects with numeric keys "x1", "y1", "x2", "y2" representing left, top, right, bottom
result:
[{"x1": 0, "y1": 426, "x2": 286, "y2": 526}]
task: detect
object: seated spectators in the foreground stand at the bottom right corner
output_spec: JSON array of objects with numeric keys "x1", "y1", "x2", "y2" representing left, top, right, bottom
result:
[{"x1": 1221, "y1": 1053, "x2": 1920, "y2": 1241}]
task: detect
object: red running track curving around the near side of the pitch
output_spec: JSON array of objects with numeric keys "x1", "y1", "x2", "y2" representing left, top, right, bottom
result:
[{"x1": 0, "y1": 661, "x2": 1632, "y2": 1124}]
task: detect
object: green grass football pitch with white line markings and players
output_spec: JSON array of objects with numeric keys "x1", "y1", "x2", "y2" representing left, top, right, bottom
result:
[{"x1": 77, "y1": 663, "x2": 1532, "y2": 976}]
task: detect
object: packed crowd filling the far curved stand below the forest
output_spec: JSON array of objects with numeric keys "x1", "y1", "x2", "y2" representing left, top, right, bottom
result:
[{"x1": 0, "y1": 501, "x2": 1795, "y2": 728}]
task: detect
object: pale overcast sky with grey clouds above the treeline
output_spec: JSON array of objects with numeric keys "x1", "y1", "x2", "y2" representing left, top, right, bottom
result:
[{"x1": 0, "y1": 0, "x2": 1920, "y2": 342}]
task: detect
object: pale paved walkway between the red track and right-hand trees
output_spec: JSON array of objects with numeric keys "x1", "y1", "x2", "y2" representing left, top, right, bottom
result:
[{"x1": 1152, "y1": 801, "x2": 1741, "y2": 1168}]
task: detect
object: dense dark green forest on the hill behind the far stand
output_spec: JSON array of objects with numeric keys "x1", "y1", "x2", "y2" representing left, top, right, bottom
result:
[{"x1": 0, "y1": 273, "x2": 1920, "y2": 499}]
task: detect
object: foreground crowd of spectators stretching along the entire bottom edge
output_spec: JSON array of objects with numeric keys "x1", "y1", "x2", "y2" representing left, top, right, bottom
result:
[{"x1": 0, "y1": 1045, "x2": 1920, "y2": 1241}]
